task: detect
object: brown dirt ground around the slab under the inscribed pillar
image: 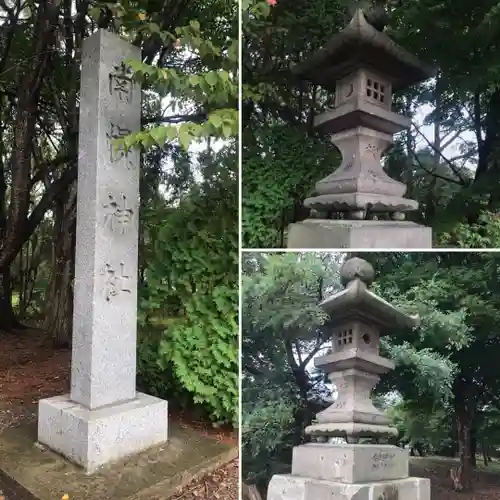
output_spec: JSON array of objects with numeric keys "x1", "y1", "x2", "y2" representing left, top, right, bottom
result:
[{"x1": 0, "y1": 330, "x2": 239, "y2": 500}]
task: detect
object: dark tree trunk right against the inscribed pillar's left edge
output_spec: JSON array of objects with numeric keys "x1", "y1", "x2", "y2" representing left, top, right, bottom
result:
[{"x1": 45, "y1": 183, "x2": 76, "y2": 348}]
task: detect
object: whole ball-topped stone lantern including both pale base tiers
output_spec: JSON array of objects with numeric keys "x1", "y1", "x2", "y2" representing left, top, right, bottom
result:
[{"x1": 267, "y1": 258, "x2": 430, "y2": 500}]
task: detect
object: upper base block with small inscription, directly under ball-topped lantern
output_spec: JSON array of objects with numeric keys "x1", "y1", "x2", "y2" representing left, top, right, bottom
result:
[{"x1": 292, "y1": 443, "x2": 409, "y2": 484}]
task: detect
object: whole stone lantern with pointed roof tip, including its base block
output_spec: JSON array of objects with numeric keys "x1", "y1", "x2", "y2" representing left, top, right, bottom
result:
[{"x1": 288, "y1": 9, "x2": 434, "y2": 248}]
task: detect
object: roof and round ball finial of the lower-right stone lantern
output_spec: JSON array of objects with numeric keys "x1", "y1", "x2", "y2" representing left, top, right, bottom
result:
[{"x1": 320, "y1": 257, "x2": 419, "y2": 335}]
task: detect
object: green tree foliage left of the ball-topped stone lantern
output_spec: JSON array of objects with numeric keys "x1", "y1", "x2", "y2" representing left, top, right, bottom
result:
[{"x1": 241, "y1": 253, "x2": 339, "y2": 490}]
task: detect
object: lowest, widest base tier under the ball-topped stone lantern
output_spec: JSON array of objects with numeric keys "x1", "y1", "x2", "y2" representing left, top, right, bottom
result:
[{"x1": 267, "y1": 475, "x2": 431, "y2": 500}]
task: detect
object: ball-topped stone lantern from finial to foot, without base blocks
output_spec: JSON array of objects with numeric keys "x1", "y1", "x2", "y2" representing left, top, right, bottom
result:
[{"x1": 305, "y1": 258, "x2": 418, "y2": 443}]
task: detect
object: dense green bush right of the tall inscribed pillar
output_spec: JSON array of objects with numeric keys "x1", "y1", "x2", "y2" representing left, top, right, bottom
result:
[{"x1": 141, "y1": 148, "x2": 239, "y2": 425}]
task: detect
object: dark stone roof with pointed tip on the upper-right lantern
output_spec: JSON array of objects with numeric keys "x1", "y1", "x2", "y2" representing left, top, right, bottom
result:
[{"x1": 292, "y1": 8, "x2": 436, "y2": 90}]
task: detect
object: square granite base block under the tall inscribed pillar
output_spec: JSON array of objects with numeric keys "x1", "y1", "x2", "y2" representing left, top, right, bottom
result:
[{"x1": 38, "y1": 393, "x2": 168, "y2": 473}]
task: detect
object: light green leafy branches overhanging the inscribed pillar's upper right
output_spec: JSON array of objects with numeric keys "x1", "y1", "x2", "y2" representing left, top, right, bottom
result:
[{"x1": 117, "y1": 2, "x2": 239, "y2": 150}]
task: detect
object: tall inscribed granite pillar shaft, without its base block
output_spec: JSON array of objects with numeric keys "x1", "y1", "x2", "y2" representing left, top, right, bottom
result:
[{"x1": 71, "y1": 30, "x2": 141, "y2": 409}]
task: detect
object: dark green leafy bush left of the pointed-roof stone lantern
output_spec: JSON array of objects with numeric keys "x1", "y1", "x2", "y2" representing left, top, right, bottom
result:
[{"x1": 242, "y1": 125, "x2": 338, "y2": 248}]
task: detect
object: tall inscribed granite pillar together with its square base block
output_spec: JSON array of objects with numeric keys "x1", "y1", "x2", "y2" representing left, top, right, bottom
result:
[{"x1": 38, "y1": 30, "x2": 168, "y2": 472}]
